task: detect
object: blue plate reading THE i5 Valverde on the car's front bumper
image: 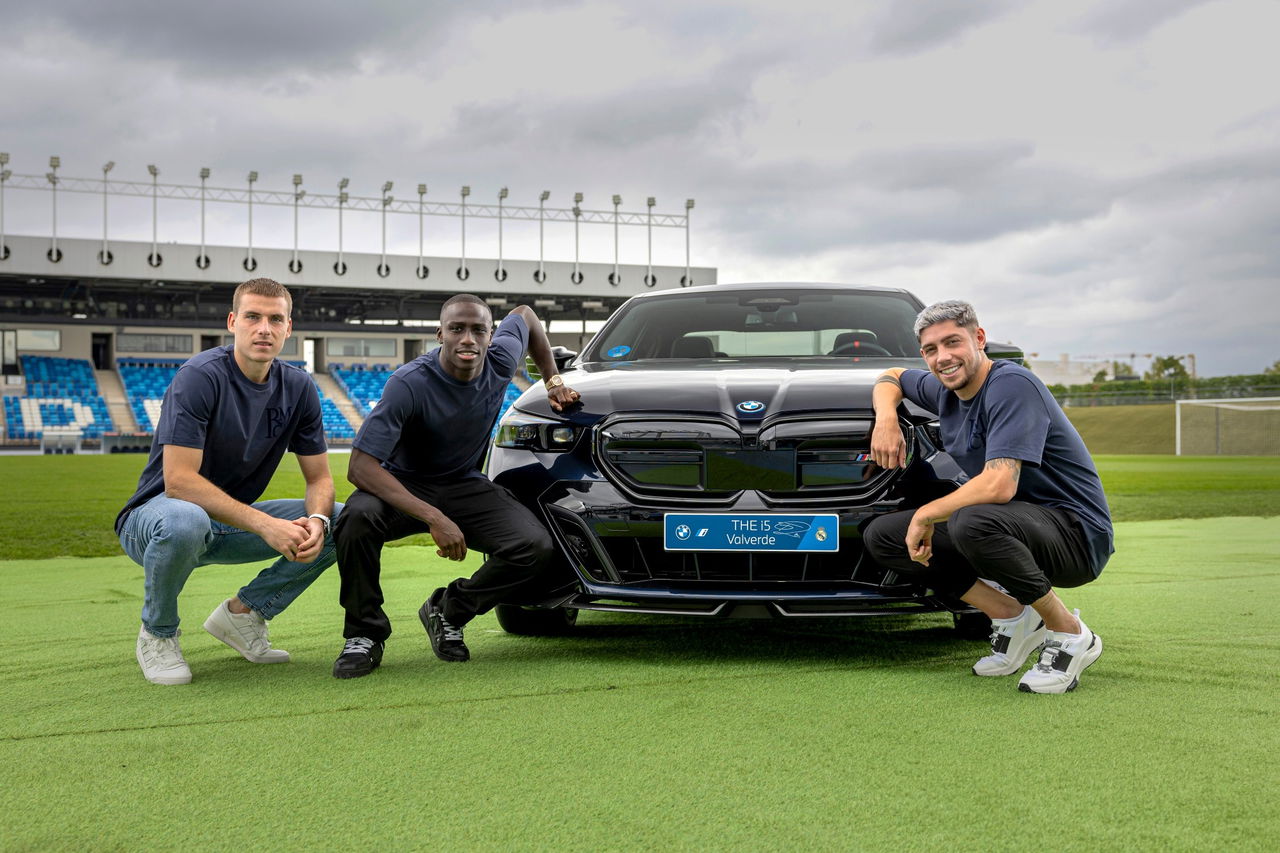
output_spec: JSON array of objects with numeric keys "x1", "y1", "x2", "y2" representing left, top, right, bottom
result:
[{"x1": 663, "y1": 512, "x2": 840, "y2": 551}]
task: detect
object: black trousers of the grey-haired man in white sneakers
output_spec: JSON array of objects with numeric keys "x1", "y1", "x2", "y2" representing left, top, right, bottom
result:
[{"x1": 863, "y1": 501, "x2": 1097, "y2": 605}]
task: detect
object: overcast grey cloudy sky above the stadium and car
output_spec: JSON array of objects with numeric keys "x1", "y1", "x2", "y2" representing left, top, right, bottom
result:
[{"x1": 0, "y1": 0, "x2": 1280, "y2": 375}]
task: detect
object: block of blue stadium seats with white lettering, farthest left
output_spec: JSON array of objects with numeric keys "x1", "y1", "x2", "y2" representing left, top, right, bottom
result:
[{"x1": 4, "y1": 355, "x2": 114, "y2": 439}]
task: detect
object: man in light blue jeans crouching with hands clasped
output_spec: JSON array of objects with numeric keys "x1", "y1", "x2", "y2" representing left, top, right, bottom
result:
[{"x1": 115, "y1": 278, "x2": 342, "y2": 684}]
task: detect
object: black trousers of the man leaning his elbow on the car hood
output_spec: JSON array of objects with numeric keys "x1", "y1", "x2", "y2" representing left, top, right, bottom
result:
[{"x1": 334, "y1": 478, "x2": 556, "y2": 642}]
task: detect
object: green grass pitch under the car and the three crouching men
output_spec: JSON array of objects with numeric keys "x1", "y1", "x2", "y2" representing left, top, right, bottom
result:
[{"x1": 0, "y1": 456, "x2": 1280, "y2": 850}]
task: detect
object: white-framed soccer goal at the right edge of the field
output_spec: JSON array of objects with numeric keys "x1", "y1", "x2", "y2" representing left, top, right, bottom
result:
[{"x1": 1175, "y1": 397, "x2": 1280, "y2": 456}]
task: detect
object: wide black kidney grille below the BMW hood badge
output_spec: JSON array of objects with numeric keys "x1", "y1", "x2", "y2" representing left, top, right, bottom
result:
[{"x1": 595, "y1": 415, "x2": 892, "y2": 501}]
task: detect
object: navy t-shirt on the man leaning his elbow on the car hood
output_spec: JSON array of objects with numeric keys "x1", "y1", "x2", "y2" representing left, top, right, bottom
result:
[{"x1": 353, "y1": 314, "x2": 529, "y2": 484}]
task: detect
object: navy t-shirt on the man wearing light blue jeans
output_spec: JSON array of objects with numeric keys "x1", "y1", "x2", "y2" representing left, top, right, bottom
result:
[{"x1": 115, "y1": 346, "x2": 325, "y2": 534}]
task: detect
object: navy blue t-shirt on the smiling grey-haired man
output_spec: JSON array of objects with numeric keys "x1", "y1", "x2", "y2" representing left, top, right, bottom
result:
[{"x1": 900, "y1": 360, "x2": 1115, "y2": 575}]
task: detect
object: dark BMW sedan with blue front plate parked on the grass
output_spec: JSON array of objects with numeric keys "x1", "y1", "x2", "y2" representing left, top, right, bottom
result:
[{"x1": 488, "y1": 283, "x2": 1021, "y2": 634}]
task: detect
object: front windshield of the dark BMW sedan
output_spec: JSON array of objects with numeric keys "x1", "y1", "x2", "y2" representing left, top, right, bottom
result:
[{"x1": 585, "y1": 288, "x2": 920, "y2": 361}]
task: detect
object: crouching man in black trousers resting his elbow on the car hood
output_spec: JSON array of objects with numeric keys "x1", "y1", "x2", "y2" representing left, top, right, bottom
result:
[{"x1": 333, "y1": 293, "x2": 579, "y2": 678}]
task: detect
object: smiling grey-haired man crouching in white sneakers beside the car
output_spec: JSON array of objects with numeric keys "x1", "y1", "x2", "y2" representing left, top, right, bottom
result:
[{"x1": 863, "y1": 300, "x2": 1114, "y2": 693}]
